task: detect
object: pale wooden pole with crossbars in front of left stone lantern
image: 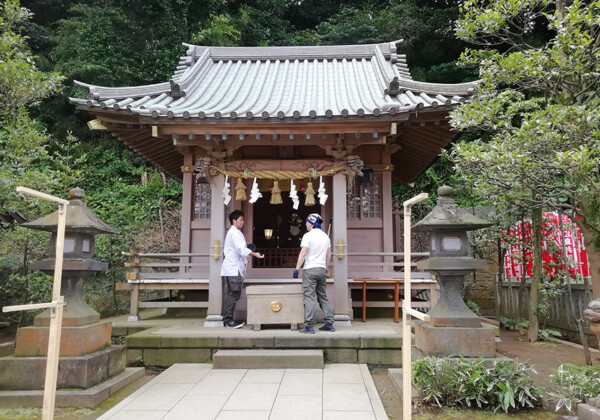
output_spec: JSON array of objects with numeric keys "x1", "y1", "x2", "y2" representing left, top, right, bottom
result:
[{"x1": 3, "y1": 187, "x2": 69, "y2": 420}]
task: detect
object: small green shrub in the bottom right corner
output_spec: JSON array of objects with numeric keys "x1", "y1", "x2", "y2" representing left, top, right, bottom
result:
[{"x1": 548, "y1": 363, "x2": 600, "y2": 413}]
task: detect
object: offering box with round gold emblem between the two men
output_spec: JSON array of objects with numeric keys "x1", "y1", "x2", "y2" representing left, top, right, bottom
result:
[{"x1": 246, "y1": 284, "x2": 304, "y2": 330}]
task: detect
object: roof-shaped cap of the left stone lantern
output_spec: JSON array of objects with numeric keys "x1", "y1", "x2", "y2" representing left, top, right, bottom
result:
[{"x1": 21, "y1": 188, "x2": 119, "y2": 235}]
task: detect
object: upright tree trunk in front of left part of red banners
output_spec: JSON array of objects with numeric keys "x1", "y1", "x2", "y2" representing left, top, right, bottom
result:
[{"x1": 527, "y1": 208, "x2": 543, "y2": 342}]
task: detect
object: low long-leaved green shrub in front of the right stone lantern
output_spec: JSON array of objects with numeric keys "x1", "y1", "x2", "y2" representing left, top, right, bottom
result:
[{"x1": 413, "y1": 356, "x2": 543, "y2": 412}]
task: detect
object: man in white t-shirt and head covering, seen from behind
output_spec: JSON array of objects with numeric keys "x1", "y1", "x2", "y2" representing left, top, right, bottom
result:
[{"x1": 292, "y1": 213, "x2": 335, "y2": 334}]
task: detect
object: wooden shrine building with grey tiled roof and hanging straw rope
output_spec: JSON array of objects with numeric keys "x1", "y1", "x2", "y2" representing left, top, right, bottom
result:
[{"x1": 70, "y1": 43, "x2": 476, "y2": 325}]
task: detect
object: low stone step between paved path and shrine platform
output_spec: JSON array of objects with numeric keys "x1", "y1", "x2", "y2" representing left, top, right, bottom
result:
[{"x1": 213, "y1": 349, "x2": 323, "y2": 369}]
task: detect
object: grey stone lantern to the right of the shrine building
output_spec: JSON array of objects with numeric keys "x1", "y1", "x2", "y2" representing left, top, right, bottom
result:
[{"x1": 414, "y1": 186, "x2": 496, "y2": 357}]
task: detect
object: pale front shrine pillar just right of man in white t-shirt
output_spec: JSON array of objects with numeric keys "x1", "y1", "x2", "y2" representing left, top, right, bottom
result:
[{"x1": 331, "y1": 173, "x2": 351, "y2": 326}]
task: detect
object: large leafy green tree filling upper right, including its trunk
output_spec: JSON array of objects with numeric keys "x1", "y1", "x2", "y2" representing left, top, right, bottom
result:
[{"x1": 452, "y1": 0, "x2": 600, "y2": 341}]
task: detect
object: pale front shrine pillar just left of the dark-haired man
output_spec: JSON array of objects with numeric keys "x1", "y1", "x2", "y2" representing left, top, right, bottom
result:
[{"x1": 204, "y1": 175, "x2": 225, "y2": 327}]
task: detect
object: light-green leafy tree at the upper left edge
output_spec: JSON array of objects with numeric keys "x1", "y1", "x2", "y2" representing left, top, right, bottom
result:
[{"x1": 0, "y1": 0, "x2": 62, "y2": 215}]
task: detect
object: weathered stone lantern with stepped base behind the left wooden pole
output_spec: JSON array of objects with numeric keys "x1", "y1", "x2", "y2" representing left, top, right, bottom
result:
[{"x1": 0, "y1": 188, "x2": 139, "y2": 400}]
